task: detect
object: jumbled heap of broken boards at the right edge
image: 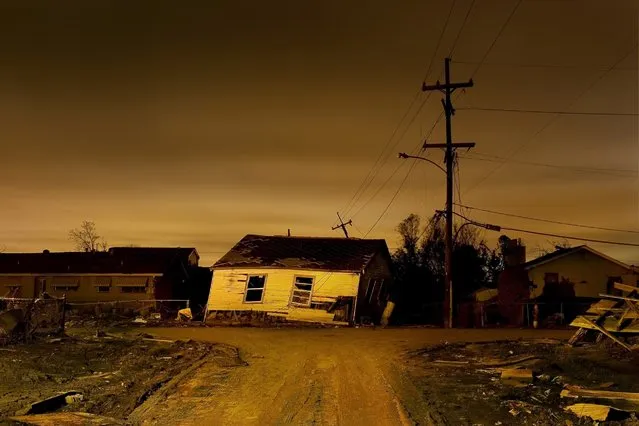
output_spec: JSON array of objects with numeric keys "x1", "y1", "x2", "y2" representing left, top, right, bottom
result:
[{"x1": 568, "y1": 283, "x2": 639, "y2": 351}]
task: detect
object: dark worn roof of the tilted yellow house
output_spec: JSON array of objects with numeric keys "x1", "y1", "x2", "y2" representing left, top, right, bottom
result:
[{"x1": 213, "y1": 235, "x2": 388, "y2": 272}]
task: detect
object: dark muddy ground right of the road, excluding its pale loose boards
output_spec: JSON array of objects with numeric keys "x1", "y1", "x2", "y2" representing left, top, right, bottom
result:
[{"x1": 406, "y1": 341, "x2": 639, "y2": 426}]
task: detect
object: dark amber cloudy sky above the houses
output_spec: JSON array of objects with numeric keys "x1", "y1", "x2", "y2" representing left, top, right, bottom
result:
[{"x1": 0, "y1": 0, "x2": 639, "y2": 265}]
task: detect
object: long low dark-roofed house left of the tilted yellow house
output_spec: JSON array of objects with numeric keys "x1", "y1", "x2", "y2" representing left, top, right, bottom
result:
[{"x1": 0, "y1": 247, "x2": 210, "y2": 305}]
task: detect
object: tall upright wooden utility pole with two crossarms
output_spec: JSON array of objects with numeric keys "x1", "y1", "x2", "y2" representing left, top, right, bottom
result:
[{"x1": 422, "y1": 58, "x2": 475, "y2": 328}]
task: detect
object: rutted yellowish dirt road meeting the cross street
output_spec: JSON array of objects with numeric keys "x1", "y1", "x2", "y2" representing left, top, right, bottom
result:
[{"x1": 130, "y1": 328, "x2": 570, "y2": 425}]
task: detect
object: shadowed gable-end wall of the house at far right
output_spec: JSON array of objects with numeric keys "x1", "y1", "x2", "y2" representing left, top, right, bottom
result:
[{"x1": 528, "y1": 250, "x2": 635, "y2": 298}]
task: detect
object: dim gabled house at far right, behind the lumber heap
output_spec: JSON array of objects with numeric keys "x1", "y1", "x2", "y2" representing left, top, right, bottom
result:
[{"x1": 524, "y1": 245, "x2": 639, "y2": 298}]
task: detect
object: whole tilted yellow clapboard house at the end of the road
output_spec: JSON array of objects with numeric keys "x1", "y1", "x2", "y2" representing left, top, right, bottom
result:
[{"x1": 207, "y1": 235, "x2": 392, "y2": 323}]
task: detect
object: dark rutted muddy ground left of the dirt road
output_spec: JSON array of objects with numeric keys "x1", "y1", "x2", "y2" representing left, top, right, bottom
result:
[{"x1": 0, "y1": 335, "x2": 236, "y2": 423}]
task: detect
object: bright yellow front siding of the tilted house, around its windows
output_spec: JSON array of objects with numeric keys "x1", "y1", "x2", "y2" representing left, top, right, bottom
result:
[{"x1": 207, "y1": 268, "x2": 359, "y2": 321}]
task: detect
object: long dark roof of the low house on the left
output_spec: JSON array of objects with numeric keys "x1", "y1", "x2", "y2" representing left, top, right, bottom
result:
[{"x1": 0, "y1": 247, "x2": 197, "y2": 274}]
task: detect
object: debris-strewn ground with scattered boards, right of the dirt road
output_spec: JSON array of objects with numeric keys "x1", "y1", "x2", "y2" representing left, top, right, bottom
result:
[{"x1": 411, "y1": 339, "x2": 639, "y2": 425}]
